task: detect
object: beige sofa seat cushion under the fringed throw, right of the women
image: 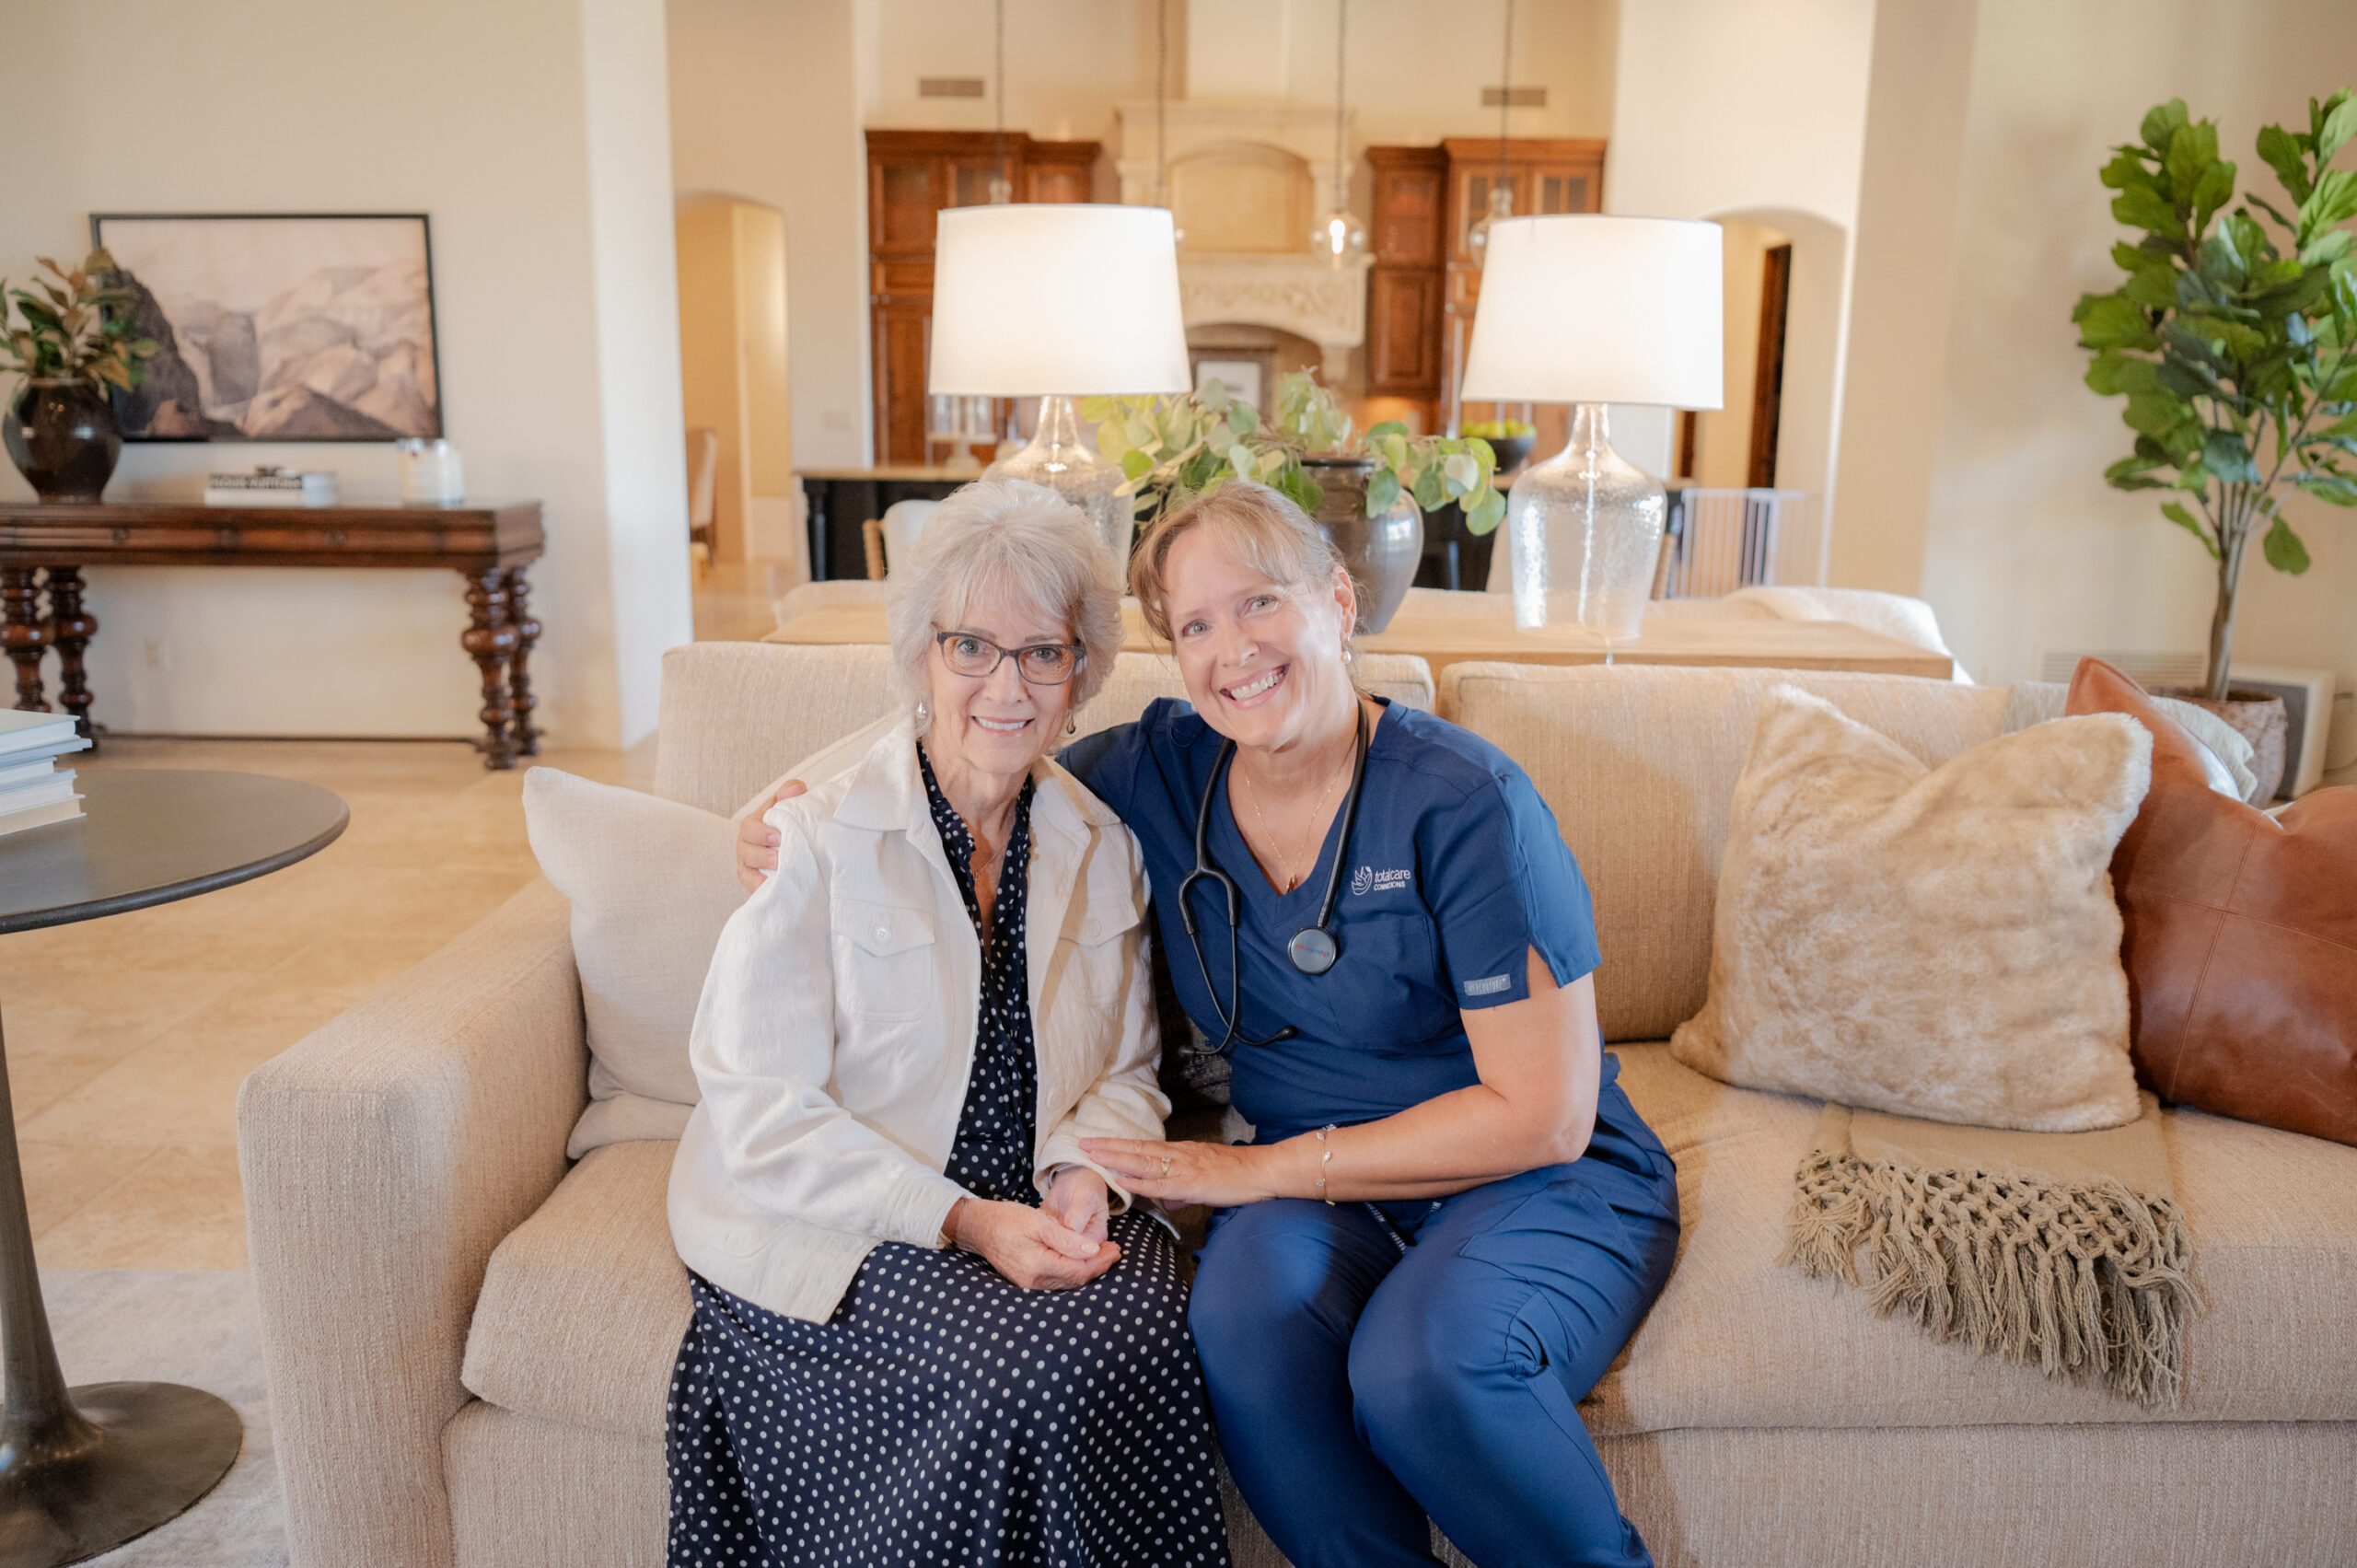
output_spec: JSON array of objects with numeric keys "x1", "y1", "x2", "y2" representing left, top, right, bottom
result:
[{"x1": 1586, "y1": 1044, "x2": 2357, "y2": 1436}]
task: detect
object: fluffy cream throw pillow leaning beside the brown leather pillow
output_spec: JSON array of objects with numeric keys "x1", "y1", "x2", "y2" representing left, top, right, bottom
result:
[{"x1": 1671, "y1": 686, "x2": 2152, "y2": 1132}]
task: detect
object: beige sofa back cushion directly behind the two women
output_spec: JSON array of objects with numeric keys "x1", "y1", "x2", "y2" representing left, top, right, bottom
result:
[{"x1": 656, "y1": 642, "x2": 1433, "y2": 816}]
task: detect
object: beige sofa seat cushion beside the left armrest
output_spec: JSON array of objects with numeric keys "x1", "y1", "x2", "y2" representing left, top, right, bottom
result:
[{"x1": 459, "y1": 1139, "x2": 695, "y2": 1438}]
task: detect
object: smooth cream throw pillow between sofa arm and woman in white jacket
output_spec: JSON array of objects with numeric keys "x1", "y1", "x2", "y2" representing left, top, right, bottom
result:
[{"x1": 523, "y1": 769, "x2": 745, "y2": 1160}]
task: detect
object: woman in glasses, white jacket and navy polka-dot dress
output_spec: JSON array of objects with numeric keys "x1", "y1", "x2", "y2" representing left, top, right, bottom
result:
[{"x1": 669, "y1": 483, "x2": 1228, "y2": 1568}]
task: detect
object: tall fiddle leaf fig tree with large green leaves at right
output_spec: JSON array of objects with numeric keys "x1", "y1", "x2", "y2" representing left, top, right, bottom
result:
[{"x1": 2072, "y1": 87, "x2": 2357, "y2": 701}]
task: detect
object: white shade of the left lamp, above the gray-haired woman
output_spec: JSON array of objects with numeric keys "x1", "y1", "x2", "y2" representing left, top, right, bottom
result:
[{"x1": 926, "y1": 203, "x2": 1192, "y2": 399}]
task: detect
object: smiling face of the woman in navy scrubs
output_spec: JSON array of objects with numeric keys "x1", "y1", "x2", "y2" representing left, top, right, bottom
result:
[{"x1": 1162, "y1": 526, "x2": 1358, "y2": 749}]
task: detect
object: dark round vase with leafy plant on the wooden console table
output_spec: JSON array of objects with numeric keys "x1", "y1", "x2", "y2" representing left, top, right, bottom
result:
[{"x1": 0, "y1": 250, "x2": 156, "y2": 502}]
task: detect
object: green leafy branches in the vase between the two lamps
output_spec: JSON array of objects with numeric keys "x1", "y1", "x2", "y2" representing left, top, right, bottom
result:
[{"x1": 1079, "y1": 370, "x2": 1506, "y2": 533}]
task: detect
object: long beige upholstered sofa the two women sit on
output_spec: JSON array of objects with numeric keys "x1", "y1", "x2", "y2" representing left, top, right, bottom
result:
[{"x1": 238, "y1": 644, "x2": 2357, "y2": 1568}]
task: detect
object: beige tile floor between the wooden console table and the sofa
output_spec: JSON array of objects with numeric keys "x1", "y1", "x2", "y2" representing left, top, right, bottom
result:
[{"x1": 0, "y1": 738, "x2": 653, "y2": 1269}]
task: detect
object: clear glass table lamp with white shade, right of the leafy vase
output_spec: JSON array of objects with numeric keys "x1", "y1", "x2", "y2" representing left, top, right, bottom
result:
[{"x1": 1464, "y1": 215, "x2": 1725, "y2": 636}]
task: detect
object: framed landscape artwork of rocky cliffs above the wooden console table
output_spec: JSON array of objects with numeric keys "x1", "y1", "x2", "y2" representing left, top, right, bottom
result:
[{"x1": 89, "y1": 212, "x2": 443, "y2": 441}]
